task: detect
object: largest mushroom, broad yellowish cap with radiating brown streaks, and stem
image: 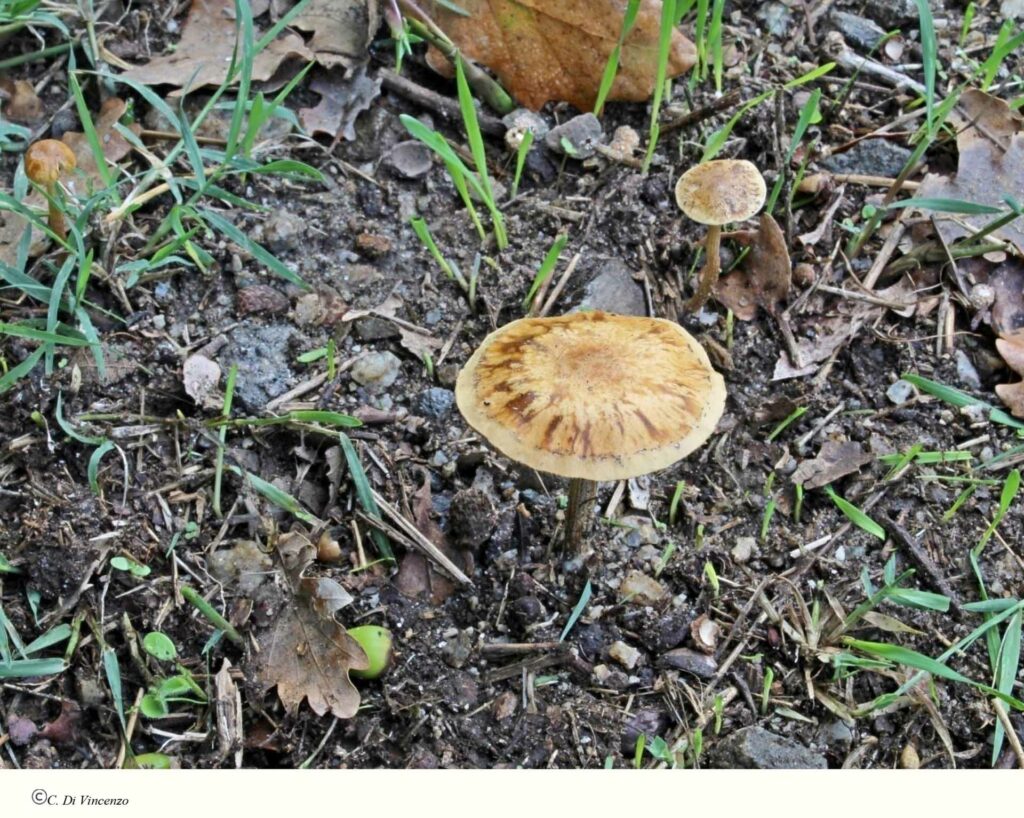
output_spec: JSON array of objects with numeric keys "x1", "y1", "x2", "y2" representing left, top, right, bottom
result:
[{"x1": 456, "y1": 311, "x2": 725, "y2": 552}]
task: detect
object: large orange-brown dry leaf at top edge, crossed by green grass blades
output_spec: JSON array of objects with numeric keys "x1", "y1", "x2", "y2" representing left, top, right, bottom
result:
[{"x1": 426, "y1": 0, "x2": 696, "y2": 111}]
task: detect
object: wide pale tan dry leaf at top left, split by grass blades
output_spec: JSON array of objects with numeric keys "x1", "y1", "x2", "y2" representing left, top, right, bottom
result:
[{"x1": 117, "y1": 0, "x2": 312, "y2": 88}]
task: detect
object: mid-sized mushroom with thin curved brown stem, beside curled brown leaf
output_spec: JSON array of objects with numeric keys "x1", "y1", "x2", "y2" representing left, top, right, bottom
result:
[{"x1": 676, "y1": 159, "x2": 767, "y2": 312}]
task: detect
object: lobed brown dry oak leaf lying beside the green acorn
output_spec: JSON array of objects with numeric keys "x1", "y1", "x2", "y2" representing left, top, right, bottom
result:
[{"x1": 256, "y1": 577, "x2": 370, "y2": 719}]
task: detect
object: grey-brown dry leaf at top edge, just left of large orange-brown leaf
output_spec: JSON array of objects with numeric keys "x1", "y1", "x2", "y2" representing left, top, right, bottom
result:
[{"x1": 291, "y1": 0, "x2": 381, "y2": 68}]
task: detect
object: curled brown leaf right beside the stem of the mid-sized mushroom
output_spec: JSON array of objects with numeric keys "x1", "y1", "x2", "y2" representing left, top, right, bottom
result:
[{"x1": 715, "y1": 213, "x2": 793, "y2": 320}]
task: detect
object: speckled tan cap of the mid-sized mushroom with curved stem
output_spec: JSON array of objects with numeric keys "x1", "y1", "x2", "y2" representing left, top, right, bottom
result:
[{"x1": 676, "y1": 159, "x2": 768, "y2": 225}]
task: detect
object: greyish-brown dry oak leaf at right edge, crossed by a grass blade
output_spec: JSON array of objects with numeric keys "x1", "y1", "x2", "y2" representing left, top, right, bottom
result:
[{"x1": 916, "y1": 89, "x2": 1024, "y2": 254}]
